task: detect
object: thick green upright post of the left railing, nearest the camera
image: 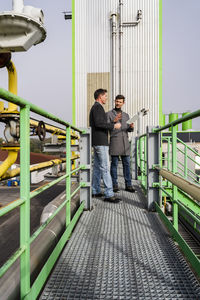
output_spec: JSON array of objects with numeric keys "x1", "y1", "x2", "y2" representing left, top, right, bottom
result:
[{"x1": 20, "y1": 105, "x2": 30, "y2": 299}]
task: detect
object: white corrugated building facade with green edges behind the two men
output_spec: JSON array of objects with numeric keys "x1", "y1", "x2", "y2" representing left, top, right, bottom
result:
[{"x1": 72, "y1": 0, "x2": 162, "y2": 132}]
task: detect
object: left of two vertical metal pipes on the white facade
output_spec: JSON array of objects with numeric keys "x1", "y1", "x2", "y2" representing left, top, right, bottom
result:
[{"x1": 111, "y1": 13, "x2": 117, "y2": 107}]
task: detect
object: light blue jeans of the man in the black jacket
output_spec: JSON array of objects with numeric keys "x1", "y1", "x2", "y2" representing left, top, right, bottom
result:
[{"x1": 92, "y1": 146, "x2": 114, "y2": 198}]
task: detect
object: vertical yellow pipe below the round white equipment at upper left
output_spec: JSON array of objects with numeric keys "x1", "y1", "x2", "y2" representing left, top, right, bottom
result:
[{"x1": 6, "y1": 61, "x2": 19, "y2": 113}]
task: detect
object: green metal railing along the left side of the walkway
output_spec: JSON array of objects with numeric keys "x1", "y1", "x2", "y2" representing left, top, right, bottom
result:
[{"x1": 0, "y1": 89, "x2": 88, "y2": 299}]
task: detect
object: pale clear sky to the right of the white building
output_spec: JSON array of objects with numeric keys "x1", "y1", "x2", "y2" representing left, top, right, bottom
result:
[{"x1": 163, "y1": 0, "x2": 200, "y2": 129}]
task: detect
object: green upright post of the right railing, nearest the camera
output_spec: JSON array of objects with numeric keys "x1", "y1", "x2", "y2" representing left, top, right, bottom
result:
[{"x1": 171, "y1": 125, "x2": 178, "y2": 231}]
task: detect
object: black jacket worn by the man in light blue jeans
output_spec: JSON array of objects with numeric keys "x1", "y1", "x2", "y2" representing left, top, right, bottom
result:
[{"x1": 89, "y1": 101, "x2": 114, "y2": 146}]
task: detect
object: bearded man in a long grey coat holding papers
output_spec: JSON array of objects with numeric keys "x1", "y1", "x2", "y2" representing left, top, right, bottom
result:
[{"x1": 107, "y1": 95, "x2": 135, "y2": 193}]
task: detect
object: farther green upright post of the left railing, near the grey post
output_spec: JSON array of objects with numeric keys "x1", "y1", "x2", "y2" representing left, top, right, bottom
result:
[{"x1": 66, "y1": 127, "x2": 71, "y2": 226}]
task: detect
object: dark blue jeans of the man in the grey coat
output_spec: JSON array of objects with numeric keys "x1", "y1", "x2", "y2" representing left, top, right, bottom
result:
[{"x1": 110, "y1": 155, "x2": 132, "y2": 186}]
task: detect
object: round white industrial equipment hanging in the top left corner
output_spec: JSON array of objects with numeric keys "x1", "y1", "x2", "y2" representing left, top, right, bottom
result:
[{"x1": 0, "y1": 0, "x2": 46, "y2": 53}]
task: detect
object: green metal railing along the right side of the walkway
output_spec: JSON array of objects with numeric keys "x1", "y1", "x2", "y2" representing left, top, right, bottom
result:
[{"x1": 136, "y1": 110, "x2": 200, "y2": 276}]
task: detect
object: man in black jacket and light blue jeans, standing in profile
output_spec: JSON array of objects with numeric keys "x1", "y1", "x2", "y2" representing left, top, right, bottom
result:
[{"x1": 90, "y1": 89, "x2": 121, "y2": 201}]
